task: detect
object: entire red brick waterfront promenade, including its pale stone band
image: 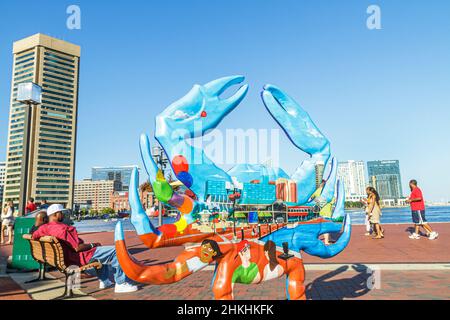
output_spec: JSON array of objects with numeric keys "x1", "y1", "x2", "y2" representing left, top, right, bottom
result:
[{"x1": 0, "y1": 223, "x2": 450, "y2": 300}]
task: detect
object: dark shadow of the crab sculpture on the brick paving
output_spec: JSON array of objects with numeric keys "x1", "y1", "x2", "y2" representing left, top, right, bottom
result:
[{"x1": 306, "y1": 264, "x2": 372, "y2": 300}]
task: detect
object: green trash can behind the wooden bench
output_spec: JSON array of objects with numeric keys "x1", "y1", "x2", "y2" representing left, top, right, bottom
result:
[{"x1": 11, "y1": 217, "x2": 39, "y2": 270}]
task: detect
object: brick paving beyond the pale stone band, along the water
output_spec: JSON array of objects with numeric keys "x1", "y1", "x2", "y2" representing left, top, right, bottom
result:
[{"x1": 75, "y1": 223, "x2": 450, "y2": 264}]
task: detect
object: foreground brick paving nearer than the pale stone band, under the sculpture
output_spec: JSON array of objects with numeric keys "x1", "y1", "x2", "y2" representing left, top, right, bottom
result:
[{"x1": 44, "y1": 267, "x2": 450, "y2": 300}]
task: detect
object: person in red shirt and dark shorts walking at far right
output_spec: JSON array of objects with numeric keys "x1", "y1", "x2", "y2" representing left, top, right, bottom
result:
[{"x1": 406, "y1": 180, "x2": 439, "y2": 240}]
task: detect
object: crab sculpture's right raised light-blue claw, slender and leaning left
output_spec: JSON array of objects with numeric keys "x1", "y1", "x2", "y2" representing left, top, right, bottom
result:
[{"x1": 262, "y1": 84, "x2": 330, "y2": 203}]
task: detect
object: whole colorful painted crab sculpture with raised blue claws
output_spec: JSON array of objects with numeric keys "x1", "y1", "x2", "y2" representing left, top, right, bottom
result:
[{"x1": 115, "y1": 76, "x2": 351, "y2": 299}]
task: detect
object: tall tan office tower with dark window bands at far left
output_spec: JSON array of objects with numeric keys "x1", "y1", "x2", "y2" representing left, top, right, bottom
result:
[{"x1": 4, "y1": 34, "x2": 80, "y2": 208}]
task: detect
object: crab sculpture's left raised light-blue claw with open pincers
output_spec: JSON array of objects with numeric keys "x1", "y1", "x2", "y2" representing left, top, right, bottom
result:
[{"x1": 150, "y1": 76, "x2": 248, "y2": 201}]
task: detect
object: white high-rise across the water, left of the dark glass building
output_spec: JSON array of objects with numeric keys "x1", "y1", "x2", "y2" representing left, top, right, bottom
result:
[{"x1": 337, "y1": 160, "x2": 367, "y2": 201}]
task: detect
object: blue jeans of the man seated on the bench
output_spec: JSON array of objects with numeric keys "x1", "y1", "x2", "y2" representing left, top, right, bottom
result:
[{"x1": 90, "y1": 246, "x2": 129, "y2": 284}]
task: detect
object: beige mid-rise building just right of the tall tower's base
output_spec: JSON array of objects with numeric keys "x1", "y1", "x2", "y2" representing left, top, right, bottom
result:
[{"x1": 74, "y1": 179, "x2": 122, "y2": 210}]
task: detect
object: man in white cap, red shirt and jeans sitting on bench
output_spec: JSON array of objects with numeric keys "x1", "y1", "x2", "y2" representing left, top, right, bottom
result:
[{"x1": 32, "y1": 204, "x2": 138, "y2": 293}]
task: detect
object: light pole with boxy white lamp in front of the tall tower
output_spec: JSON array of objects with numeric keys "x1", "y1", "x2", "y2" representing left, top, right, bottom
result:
[{"x1": 16, "y1": 82, "x2": 42, "y2": 215}]
